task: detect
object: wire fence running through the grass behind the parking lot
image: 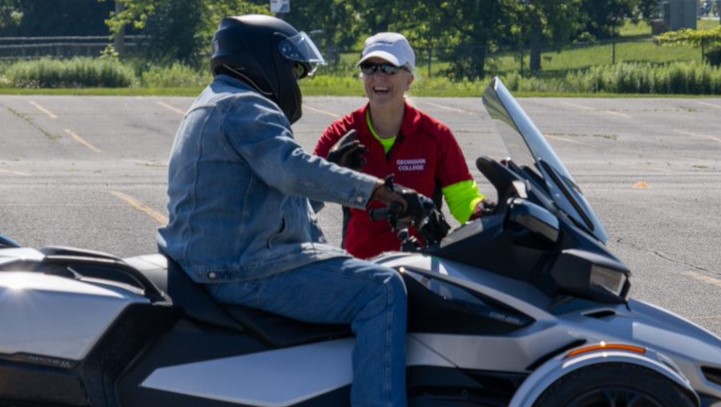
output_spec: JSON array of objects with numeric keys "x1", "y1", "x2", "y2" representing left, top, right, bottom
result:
[{"x1": 0, "y1": 35, "x2": 705, "y2": 78}]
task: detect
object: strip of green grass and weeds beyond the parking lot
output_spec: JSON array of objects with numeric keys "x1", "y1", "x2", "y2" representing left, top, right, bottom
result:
[{"x1": 0, "y1": 20, "x2": 719, "y2": 97}]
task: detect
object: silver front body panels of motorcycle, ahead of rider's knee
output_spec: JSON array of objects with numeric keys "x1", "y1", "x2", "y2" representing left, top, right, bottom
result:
[{"x1": 376, "y1": 254, "x2": 721, "y2": 405}]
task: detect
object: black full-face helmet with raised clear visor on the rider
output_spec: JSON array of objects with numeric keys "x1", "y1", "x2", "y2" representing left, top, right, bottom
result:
[{"x1": 210, "y1": 15, "x2": 325, "y2": 123}]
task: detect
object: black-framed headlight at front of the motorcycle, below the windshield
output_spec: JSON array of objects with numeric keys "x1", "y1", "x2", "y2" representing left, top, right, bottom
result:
[{"x1": 551, "y1": 249, "x2": 631, "y2": 303}]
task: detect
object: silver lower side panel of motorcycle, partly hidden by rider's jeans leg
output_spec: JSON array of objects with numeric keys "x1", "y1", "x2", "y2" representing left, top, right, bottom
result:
[{"x1": 141, "y1": 335, "x2": 457, "y2": 407}]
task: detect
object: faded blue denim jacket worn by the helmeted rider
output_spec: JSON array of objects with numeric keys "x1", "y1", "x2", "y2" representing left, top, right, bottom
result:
[{"x1": 157, "y1": 75, "x2": 376, "y2": 283}]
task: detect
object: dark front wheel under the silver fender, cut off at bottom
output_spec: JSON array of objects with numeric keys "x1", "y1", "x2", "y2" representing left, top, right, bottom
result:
[{"x1": 533, "y1": 363, "x2": 696, "y2": 407}]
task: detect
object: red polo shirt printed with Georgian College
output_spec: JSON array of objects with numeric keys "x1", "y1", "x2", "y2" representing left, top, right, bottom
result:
[{"x1": 314, "y1": 102, "x2": 473, "y2": 258}]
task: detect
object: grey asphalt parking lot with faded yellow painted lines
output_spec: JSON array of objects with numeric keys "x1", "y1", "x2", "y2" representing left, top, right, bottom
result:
[{"x1": 0, "y1": 91, "x2": 721, "y2": 334}]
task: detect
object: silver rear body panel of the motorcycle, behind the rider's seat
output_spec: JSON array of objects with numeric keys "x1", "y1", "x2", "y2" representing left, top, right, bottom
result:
[{"x1": 0, "y1": 248, "x2": 148, "y2": 360}]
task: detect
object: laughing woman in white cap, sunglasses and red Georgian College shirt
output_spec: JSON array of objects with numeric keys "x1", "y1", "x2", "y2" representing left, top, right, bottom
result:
[{"x1": 315, "y1": 32, "x2": 485, "y2": 258}]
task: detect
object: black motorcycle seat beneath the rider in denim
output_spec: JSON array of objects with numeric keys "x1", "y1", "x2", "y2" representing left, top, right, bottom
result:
[{"x1": 158, "y1": 256, "x2": 351, "y2": 347}]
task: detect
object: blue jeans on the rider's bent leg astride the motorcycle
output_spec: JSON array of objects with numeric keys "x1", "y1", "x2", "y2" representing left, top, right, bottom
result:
[{"x1": 209, "y1": 257, "x2": 408, "y2": 407}]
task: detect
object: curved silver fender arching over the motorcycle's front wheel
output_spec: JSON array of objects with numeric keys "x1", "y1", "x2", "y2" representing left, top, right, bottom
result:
[{"x1": 508, "y1": 344, "x2": 700, "y2": 407}]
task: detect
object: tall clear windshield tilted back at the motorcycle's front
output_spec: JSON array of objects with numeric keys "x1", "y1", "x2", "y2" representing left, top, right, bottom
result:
[{"x1": 483, "y1": 78, "x2": 607, "y2": 243}]
